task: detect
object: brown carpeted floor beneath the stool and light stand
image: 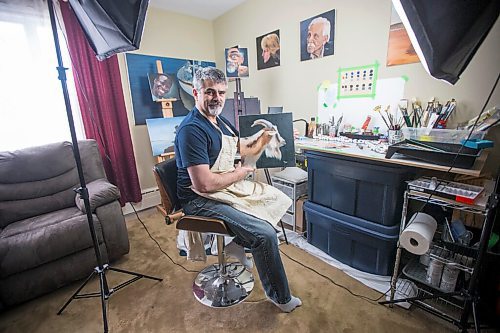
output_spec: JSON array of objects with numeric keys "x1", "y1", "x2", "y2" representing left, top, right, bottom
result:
[{"x1": 0, "y1": 209, "x2": 453, "y2": 333}]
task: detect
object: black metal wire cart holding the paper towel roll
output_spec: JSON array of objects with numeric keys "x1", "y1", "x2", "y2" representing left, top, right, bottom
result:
[{"x1": 380, "y1": 175, "x2": 499, "y2": 332}]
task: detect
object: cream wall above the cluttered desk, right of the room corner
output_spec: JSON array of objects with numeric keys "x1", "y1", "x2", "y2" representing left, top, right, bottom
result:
[{"x1": 214, "y1": 0, "x2": 500, "y2": 123}]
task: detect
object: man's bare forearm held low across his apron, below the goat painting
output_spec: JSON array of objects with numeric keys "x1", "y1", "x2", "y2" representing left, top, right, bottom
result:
[{"x1": 187, "y1": 162, "x2": 254, "y2": 193}]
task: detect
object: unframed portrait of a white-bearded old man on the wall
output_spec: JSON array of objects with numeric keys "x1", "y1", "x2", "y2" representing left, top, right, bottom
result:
[{"x1": 300, "y1": 9, "x2": 335, "y2": 61}]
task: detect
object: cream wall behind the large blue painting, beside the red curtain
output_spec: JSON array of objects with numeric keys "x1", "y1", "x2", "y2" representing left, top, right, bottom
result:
[{"x1": 119, "y1": 8, "x2": 215, "y2": 191}]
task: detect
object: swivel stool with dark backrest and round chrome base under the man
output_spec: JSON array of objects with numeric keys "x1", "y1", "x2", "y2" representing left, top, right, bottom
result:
[{"x1": 153, "y1": 159, "x2": 254, "y2": 308}]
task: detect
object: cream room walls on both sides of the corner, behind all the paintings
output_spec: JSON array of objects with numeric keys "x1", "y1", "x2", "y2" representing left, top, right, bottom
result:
[{"x1": 119, "y1": 0, "x2": 500, "y2": 196}]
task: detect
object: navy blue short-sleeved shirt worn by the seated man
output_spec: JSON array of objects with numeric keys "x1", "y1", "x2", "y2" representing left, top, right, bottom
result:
[{"x1": 175, "y1": 108, "x2": 239, "y2": 205}]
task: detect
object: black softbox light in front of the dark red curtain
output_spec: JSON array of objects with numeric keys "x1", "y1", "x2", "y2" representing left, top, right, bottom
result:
[{"x1": 69, "y1": 0, "x2": 149, "y2": 60}]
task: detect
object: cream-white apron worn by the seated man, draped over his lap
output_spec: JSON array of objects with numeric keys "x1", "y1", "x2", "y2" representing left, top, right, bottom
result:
[{"x1": 192, "y1": 115, "x2": 292, "y2": 227}]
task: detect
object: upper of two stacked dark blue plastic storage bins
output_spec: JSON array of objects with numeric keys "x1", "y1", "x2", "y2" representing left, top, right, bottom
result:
[{"x1": 306, "y1": 151, "x2": 413, "y2": 226}]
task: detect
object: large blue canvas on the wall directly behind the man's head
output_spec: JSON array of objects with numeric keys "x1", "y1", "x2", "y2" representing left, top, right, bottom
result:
[{"x1": 125, "y1": 53, "x2": 215, "y2": 125}]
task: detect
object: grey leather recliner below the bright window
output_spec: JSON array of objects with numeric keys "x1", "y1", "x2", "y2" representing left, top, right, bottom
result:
[{"x1": 0, "y1": 140, "x2": 129, "y2": 310}]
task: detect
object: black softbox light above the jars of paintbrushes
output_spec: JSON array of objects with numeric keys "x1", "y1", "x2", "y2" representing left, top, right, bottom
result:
[{"x1": 392, "y1": 0, "x2": 500, "y2": 84}]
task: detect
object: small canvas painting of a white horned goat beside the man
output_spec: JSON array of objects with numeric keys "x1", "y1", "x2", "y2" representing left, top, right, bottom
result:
[{"x1": 239, "y1": 113, "x2": 295, "y2": 169}]
